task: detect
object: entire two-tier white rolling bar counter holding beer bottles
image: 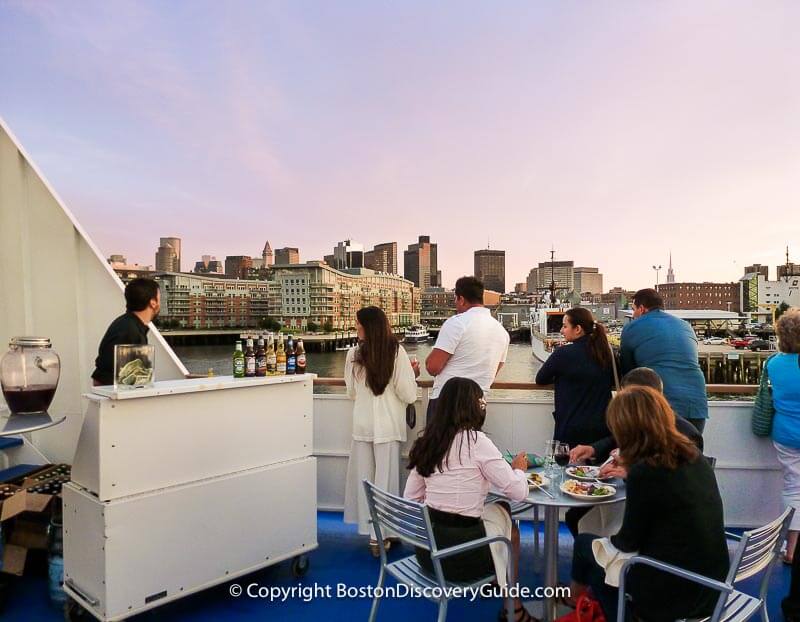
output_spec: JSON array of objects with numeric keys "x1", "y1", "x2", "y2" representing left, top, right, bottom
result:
[{"x1": 63, "y1": 374, "x2": 317, "y2": 620}]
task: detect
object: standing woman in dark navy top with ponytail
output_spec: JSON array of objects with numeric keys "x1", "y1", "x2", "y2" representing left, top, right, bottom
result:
[{"x1": 536, "y1": 307, "x2": 614, "y2": 535}]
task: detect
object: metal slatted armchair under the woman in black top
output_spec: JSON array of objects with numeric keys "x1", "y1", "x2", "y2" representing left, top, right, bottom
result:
[{"x1": 617, "y1": 508, "x2": 794, "y2": 622}]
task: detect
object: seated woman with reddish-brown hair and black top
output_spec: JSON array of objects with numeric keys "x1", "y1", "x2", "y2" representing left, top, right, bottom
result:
[{"x1": 572, "y1": 386, "x2": 729, "y2": 621}]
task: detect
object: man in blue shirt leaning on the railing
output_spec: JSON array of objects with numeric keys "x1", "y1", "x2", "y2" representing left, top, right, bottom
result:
[{"x1": 620, "y1": 289, "x2": 708, "y2": 434}]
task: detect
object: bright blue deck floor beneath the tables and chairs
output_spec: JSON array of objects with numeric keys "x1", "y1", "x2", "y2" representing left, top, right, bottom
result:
[{"x1": 7, "y1": 512, "x2": 790, "y2": 622}]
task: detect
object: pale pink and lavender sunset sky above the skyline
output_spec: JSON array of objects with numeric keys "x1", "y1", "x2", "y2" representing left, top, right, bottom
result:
[{"x1": 0, "y1": 0, "x2": 800, "y2": 289}]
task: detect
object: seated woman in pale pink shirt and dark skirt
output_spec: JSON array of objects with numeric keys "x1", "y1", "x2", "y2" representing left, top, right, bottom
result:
[{"x1": 404, "y1": 378, "x2": 533, "y2": 622}]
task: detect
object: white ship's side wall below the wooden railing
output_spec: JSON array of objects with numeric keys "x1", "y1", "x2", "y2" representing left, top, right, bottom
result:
[{"x1": 314, "y1": 395, "x2": 782, "y2": 527}]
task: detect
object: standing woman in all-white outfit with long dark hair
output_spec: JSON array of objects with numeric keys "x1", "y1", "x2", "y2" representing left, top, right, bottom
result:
[{"x1": 344, "y1": 307, "x2": 419, "y2": 557}]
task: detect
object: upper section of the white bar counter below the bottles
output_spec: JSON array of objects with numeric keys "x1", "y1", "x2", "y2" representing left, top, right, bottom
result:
[{"x1": 72, "y1": 374, "x2": 314, "y2": 501}]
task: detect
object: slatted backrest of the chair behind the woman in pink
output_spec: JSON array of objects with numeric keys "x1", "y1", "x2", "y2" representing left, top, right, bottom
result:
[{"x1": 364, "y1": 480, "x2": 435, "y2": 551}]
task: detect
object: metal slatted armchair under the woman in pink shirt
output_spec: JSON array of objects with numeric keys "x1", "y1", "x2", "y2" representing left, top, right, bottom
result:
[{"x1": 364, "y1": 480, "x2": 514, "y2": 622}]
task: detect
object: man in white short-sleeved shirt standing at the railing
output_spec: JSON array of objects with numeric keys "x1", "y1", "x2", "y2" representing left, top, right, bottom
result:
[{"x1": 425, "y1": 276, "x2": 509, "y2": 421}]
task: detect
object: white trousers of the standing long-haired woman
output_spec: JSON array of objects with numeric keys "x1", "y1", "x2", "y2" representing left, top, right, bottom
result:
[{"x1": 344, "y1": 441, "x2": 400, "y2": 539}]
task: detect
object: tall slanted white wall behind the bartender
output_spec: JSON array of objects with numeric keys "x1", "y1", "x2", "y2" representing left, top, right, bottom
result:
[{"x1": 0, "y1": 119, "x2": 186, "y2": 462}]
